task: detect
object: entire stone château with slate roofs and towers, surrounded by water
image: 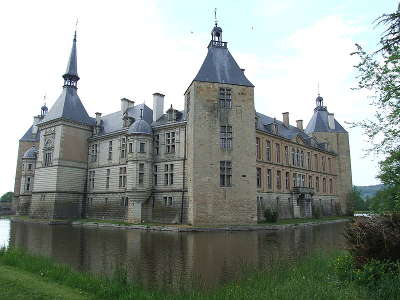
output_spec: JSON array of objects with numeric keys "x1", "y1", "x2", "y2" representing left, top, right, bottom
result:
[{"x1": 14, "y1": 23, "x2": 352, "y2": 225}]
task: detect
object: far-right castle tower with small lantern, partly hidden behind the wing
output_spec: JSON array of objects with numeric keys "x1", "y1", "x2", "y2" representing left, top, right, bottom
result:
[{"x1": 305, "y1": 93, "x2": 352, "y2": 214}]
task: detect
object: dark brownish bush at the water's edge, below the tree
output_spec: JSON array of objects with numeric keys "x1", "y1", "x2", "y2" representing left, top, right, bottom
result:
[{"x1": 345, "y1": 214, "x2": 400, "y2": 268}]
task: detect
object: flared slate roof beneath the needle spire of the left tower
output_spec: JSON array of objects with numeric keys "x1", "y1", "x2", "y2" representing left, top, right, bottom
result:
[{"x1": 41, "y1": 86, "x2": 95, "y2": 125}]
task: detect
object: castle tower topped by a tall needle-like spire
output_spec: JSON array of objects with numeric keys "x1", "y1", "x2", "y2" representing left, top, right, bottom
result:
[{"x1": 30, "y1": 32, "x2": 95, "y2": 218}]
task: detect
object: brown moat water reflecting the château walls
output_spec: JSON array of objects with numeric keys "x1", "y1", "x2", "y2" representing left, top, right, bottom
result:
[{"x1": 0, "y1": 219, "x2": 345, "y2": 290}]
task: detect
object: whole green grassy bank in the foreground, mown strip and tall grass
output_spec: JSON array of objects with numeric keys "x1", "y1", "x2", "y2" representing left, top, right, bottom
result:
[{"x1": 0, "y1": 249, "x2": 373, "y2": 300}]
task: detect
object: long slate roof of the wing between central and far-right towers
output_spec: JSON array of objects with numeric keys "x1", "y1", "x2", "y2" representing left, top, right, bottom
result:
[{"x1": 256, "y1": 112, "x2": 327, "y2": 150}]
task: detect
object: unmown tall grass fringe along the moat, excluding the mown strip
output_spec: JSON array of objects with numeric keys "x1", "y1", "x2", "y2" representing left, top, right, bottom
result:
[{"x1": 0, "y1": 248, "x2": 369, "y2": 300}]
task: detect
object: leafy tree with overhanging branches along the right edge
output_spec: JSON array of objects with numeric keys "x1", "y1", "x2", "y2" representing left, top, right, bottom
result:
[{"x1": 352, "y1": 4, "x2": 400, "y2": 212}]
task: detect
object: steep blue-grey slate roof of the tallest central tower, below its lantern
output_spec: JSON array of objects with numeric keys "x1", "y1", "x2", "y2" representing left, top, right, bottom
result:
[{"x1": 193, "y1": 43, "x2": 254, "y2": 87}]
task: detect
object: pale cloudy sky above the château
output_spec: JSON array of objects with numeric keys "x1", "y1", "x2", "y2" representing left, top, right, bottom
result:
[{"x1": 0, "y1": 0, "x2": 397, "y2": 195}]
